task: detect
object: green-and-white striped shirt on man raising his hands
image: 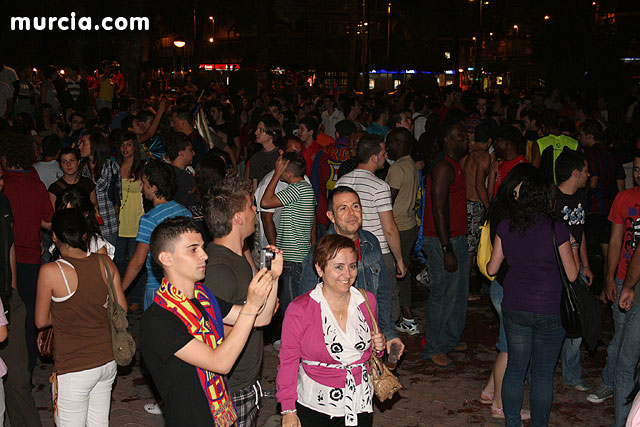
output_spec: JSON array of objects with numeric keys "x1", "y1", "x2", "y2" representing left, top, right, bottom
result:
[{"x1": 276, "y1": 179, "x2": 316, "y2": 263}]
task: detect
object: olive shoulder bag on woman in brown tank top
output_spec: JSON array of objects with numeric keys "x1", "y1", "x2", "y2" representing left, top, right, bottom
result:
[{"x1": 100, "y1": 255, "x2": 136, "y2": 366}]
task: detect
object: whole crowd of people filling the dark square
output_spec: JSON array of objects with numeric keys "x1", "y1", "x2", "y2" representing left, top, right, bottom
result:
[{"x1": 0, "y1": 60, "x2": 640, "y2": 427}]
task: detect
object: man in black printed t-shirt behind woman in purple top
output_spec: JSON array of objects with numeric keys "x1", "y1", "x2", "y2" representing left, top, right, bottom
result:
[{"x1": 556, "y1": 150, "x2": 594, "y2": 391}]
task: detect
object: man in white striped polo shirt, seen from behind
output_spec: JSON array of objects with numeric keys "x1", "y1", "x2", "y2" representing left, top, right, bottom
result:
[{"x1": 336, "y1": 135, "x2": 407, "y2": 323}]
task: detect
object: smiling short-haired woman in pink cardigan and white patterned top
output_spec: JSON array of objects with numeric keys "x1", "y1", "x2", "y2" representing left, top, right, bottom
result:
[{"x1": 276, "y1": 234, "x2": 385, "y2": 427}]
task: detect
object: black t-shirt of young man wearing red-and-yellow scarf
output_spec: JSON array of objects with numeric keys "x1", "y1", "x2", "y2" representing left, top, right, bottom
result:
[{"x1": 140, "y1": 298, "x2": 232, "y2": 427}]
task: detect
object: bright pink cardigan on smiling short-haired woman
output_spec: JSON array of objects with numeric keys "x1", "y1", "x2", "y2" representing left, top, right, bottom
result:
[{"x1": 276, "y1": 292, "x2": 378, "y2": 411}]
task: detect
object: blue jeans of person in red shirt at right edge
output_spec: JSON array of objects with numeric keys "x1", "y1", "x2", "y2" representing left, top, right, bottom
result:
[{"x1": 607, "y1": 291, "x2": 640, "y2": 427}]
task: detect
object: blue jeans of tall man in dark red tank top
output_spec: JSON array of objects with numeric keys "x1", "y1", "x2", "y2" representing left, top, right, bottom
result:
[{"x1": 422, "y1": 236, "x2": 469, "y2": 359}]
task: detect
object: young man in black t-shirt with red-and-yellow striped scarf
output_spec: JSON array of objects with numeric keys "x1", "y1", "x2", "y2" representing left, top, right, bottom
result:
[{"x1": 140, "y1": 217, "x2": 282, "y2": 427}]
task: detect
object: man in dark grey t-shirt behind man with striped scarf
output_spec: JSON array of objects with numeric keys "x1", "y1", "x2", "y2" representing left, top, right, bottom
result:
[{"x1": 204, "y1": 177, "x2": 282, "y2": 427}]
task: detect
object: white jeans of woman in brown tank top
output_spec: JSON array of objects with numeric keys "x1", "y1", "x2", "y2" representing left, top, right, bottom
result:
[{"x1": 54, "y1": 360, "x2": 117, "y2": 427}]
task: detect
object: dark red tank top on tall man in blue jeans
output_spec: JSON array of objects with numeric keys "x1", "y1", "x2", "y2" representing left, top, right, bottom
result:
[{"x1": 422, "y1": 155, "x2": 467, "y2": 237}]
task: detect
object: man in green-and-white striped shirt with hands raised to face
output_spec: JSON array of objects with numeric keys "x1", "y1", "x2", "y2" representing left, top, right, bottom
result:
[{"x1": 260, "y1": 152, "x2": 316, "y2": 320}]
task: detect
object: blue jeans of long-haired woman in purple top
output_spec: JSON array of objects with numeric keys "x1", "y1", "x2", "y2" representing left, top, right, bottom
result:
[{"x1": 502, "y1": 307, "x2": 565, "y2": 427}]
